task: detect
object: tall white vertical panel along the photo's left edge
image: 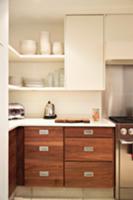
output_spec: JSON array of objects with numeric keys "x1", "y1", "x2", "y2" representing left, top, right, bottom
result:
[{"x1": 0, "y1": 0, "x2": 8, "y2": 200}]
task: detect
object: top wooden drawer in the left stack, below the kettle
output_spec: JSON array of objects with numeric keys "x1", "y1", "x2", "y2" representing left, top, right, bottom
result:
[{"x1": 24, "y1": 127, "x2": 63, "y2": 141}]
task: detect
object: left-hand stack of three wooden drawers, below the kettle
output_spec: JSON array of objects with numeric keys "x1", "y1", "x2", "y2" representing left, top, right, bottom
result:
[{"x1": 24, "y1": 127, "x2": 63, "y2": 186}]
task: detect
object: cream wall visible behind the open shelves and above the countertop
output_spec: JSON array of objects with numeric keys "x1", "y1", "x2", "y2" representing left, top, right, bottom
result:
[{"x1": 10, "y1": 23, "x2": 101, "y2": 117}]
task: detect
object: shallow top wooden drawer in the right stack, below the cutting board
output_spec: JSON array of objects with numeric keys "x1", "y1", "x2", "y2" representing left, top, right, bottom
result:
[{"x1": 65, "y1": 127, "x2": 114, "y2": 138}]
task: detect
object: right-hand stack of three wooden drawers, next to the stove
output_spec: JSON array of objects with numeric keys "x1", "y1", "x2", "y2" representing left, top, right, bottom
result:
[{"x1": 65, "y1": 127, "x2": 114, "y2": 188}]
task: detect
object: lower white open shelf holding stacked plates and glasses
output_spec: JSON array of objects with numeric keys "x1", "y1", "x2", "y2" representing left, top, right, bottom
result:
[{"x1": 8, "y1": 85, "x2": 66, "y2": 91}]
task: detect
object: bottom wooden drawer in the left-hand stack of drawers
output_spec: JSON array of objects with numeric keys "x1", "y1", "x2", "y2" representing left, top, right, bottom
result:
[{"x1": 25, "y1": 159, "x2": 63, "y2": 186}]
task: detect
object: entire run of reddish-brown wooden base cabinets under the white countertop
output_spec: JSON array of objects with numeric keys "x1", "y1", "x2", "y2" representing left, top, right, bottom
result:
[{"x1": 9, "y1": 127, "x2": 114, "y2": 194}]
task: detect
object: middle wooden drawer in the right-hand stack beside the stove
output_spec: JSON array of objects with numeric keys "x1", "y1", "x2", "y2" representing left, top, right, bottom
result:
[{"x1": 65, "y1": 138, "x2": 114, "y2": 161}]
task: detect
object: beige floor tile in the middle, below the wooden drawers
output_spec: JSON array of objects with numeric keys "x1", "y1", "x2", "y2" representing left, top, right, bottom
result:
[{"x1": 32, "y1": 187, "x2": 83, "y2": 199}]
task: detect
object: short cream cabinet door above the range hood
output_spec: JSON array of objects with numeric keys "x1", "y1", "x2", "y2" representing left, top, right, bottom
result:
[{"x1": 105, "y1": 15, "x2": 133, "y2": 60}]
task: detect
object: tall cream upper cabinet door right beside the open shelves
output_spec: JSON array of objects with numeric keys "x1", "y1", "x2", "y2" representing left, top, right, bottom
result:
[{"x1": 65, "y1": 15, "x2": 105, "y2": 90}]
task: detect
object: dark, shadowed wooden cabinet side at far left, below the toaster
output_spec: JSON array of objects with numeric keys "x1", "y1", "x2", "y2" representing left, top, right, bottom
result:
[{"x1": 8, "y1": 127, "x2": 24, "y2": 196}]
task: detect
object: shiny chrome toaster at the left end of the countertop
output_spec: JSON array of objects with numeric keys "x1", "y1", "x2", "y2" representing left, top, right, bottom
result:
[{"x1": 8, "y1": 103, "x2": 25, "y2": 120}]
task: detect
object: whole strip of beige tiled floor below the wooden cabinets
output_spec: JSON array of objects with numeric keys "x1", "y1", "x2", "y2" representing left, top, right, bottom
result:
[{"x1": 14, "y1": 187, "x2": 113, "y2": 200}]
